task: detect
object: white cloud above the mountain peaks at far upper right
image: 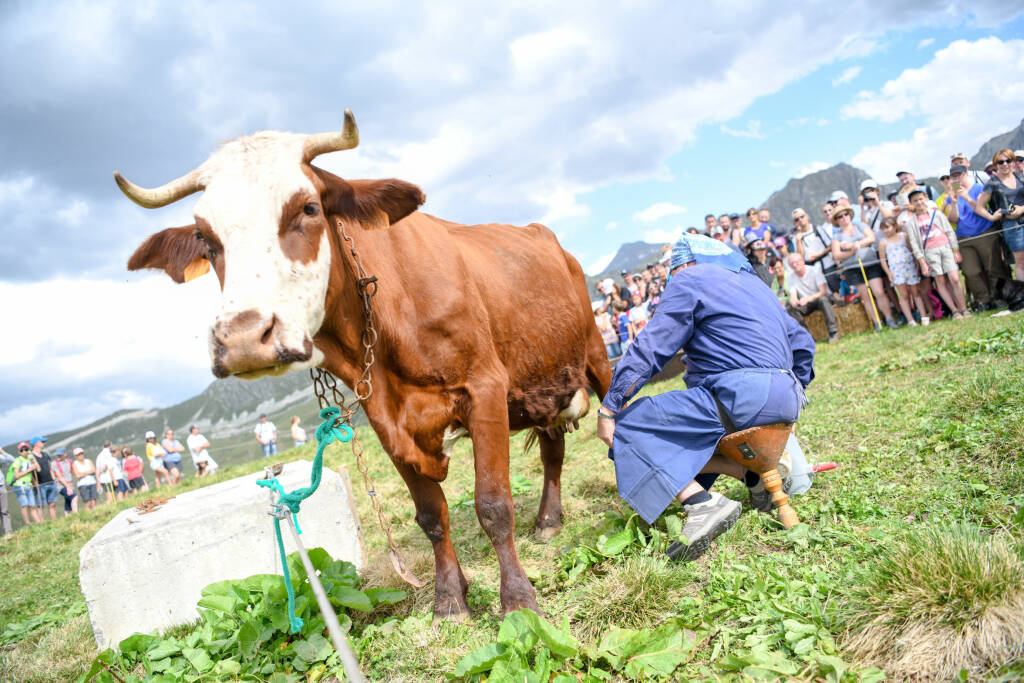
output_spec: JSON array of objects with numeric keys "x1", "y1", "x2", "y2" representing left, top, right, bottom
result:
[{"x1": 842, "y1": 37, "x2": 1024, "y2": 180}]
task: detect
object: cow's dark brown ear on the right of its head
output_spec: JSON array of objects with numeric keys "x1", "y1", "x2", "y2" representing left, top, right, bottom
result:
[{"x1": 313, "y1": 168, "x2": 427, "y2": 229}]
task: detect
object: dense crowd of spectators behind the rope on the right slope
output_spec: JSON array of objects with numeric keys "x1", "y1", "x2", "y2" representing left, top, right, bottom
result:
[{"x1": 594, "y1": 150, "x2": 1024, "y2": 358}]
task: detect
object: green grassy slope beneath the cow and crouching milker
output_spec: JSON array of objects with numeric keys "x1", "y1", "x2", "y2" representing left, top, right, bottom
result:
[{"x1": 0, "y1": 316, "x2": 1024, "y2": 681}]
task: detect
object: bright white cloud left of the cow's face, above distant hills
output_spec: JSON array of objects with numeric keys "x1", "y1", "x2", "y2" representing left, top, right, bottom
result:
[{"x1": 0, "y1": 274, "x2": 220, "y2": 443}]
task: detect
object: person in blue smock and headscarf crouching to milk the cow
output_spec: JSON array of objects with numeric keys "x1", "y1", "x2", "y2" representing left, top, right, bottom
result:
[{"x1": 597, "y1": 234, "x2": 814, "y2": 560}]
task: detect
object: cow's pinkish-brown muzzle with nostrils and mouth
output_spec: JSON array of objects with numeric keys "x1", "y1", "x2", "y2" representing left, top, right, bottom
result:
[{"x1": 210, "y1": 309, "x2": 313, "y2": 378}]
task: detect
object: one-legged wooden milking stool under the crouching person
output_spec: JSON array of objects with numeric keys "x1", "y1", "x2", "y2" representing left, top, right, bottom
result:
[{"x1": 718, "y1": 422, "x2": 800, "y2": 528}]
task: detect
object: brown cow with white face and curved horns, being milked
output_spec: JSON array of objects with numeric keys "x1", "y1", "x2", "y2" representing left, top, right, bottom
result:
[{"x1": 115, "y1": 111, "x2": 611, "y2": 616}]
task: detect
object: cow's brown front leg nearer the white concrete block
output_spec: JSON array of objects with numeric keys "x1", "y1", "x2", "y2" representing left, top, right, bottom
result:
[{"x1": 395, "y1": 462, "x2": 469, "y2": 618}]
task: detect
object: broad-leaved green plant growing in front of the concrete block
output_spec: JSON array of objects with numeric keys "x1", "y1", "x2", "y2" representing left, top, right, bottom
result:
[{"x1": 82, "y1": 548, "x2": 406, "y2": 683}]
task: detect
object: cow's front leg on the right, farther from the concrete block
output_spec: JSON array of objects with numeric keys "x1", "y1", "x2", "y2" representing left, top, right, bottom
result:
[{"x1": 468, "y1": 381, "x2": 537, "y2": 613}]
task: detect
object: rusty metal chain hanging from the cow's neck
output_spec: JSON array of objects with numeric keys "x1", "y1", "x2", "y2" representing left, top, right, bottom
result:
[{"x1": 309, "y1": 219, "x2": 425, "y2": 588}]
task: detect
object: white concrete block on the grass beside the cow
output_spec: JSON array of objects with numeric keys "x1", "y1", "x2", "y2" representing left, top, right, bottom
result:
[{"x1": 79, "y1": 460, "x2": 366, "y2": 648}]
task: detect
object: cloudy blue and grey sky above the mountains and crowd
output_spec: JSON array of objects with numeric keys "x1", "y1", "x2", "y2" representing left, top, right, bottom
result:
[{"x1": 0, "y1": 0, "x2": 1024, "y2": 443}]
